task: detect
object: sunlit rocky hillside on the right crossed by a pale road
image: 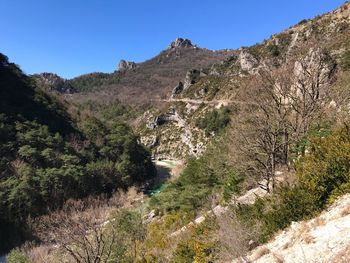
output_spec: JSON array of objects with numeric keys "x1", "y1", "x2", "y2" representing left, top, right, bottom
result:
[{"x1": 139, "y1": 4, "x2": 350, "y2": 158}]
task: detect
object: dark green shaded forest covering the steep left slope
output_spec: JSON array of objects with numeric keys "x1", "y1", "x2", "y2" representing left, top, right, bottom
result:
[{"x1": 0, "y1": 56, "x2": 156, "y2": 254}]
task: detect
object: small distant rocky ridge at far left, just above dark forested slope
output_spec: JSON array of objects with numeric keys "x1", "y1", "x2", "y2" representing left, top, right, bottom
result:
[{"x1": 32, "y1": 73, "x2": 77, "y2": 94}]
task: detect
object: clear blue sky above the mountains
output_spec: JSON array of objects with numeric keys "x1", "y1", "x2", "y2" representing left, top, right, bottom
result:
[{"x1": 0, "y1": 0, "x2": 345, "y2": 78}]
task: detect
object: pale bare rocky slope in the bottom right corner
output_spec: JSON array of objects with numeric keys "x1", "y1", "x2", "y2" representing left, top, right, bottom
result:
[{"x1": 232, "y1": 194, "x2": 350, "y2": 263}]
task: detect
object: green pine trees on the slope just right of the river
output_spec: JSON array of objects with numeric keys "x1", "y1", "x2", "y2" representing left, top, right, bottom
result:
[{"x1": 150, "y1": 134, "x2": 245, "y2": 223}]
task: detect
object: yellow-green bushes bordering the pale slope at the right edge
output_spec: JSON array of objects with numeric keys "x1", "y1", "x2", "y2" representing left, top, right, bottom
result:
[{"x1": 236, "y1": 125, "x2": 350, "y2": 242}]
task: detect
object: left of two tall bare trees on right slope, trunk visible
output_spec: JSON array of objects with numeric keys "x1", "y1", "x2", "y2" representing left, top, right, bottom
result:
[{"x1": 234, "y1": 67, "x2": 290, "y2": 192}]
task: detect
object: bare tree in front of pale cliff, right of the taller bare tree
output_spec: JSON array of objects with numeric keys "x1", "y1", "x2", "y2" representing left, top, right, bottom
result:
[{"x1": 287, "y1": 48, "x2": 335, "y2": 144}]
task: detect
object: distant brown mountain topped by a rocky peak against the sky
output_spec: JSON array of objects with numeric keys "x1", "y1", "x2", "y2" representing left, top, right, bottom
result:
[{"x1": 57, "y1": 38, "x2": 232, "y2": 106}]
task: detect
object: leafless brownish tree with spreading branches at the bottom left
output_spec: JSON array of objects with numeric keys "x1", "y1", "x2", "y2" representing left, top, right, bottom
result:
[{"x1": 32, "y1": 198, "x2": 124, "y2": 263}]
